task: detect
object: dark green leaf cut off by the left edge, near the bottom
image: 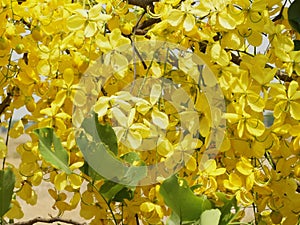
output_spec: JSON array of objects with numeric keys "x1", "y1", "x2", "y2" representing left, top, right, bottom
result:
[{"x1": 0, "y1": 168, "x2": 16, "y2": 217}]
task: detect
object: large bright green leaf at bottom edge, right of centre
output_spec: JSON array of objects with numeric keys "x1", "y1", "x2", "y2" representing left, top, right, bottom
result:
[{"x1": 160, "y1": 175, "x2": 211, "y2": 224}]
